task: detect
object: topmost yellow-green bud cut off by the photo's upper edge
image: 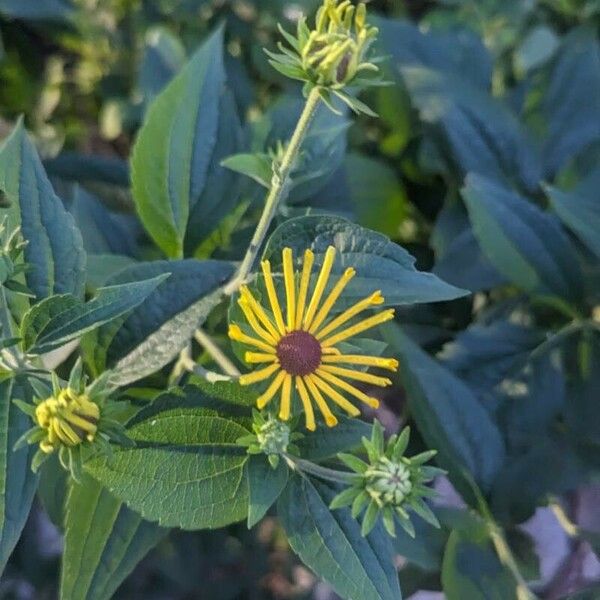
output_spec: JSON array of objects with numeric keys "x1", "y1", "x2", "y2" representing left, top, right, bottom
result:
[{"x1": 267, "y1": 0, "x2": 380, "y2": 112}]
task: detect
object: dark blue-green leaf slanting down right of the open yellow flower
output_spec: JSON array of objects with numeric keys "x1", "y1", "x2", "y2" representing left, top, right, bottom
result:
[{"x1": 383, "y1": 324, "x2": 505, "y2": 497}]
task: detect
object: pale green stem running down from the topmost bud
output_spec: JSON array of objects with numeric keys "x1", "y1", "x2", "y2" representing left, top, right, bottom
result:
[{"x1": 224, "y1": 87, "x2": 321, "y2": 296}]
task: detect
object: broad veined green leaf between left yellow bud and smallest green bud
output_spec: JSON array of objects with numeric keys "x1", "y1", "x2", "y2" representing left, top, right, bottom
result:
[{"x1": 85, "y1": 388, "x2": 249, "y2": 529}]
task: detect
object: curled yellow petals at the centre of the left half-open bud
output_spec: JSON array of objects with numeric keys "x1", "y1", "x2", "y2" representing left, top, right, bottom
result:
[{"x1": 35, "y1": 389, "x2": 100, "y2": 454}]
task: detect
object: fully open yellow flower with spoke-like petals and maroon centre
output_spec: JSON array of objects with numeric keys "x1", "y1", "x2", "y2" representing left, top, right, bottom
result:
[{"x1": 229, "y1": 246, "x2": 398, "y2": 431}]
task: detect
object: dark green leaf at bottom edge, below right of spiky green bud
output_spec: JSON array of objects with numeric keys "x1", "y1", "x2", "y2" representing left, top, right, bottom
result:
[{"x1": 442, "y1": 525, "x2": 520, "y2": 600}]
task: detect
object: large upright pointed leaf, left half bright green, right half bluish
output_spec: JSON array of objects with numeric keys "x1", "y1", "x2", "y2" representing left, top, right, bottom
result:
[{"x1": 132, "y1": 28, "x2": 240, "y2": 258}]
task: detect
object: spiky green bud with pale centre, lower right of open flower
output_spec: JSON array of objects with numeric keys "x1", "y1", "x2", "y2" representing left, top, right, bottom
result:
[{"x1": 331, "y1": 421, "x2": 444, "y2": 537}]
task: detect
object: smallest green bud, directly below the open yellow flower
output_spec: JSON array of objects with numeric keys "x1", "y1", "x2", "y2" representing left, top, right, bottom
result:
[{"x1": 237, "y1": 409, "x2": 302, "y2": 469}]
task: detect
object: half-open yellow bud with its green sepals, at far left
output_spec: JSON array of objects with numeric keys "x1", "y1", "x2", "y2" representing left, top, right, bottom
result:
[{"x1": 13, "y1": 361, "x2": 132, "y2": 480}]
